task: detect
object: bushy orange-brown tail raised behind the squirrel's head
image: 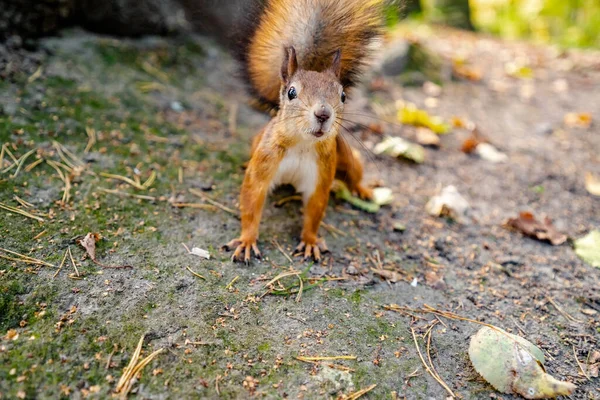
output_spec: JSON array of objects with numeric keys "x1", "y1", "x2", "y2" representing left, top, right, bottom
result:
[{"x1": 240, "y1": 0, "x2": 391, "y2": 106}]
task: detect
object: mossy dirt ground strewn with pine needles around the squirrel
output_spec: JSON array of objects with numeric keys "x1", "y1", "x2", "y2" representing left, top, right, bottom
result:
[{"x1": 0, "y1": 27, "x2": 600, "y2": 399}]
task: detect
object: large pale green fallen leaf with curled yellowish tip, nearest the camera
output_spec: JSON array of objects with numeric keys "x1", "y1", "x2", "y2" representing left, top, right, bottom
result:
[{"x1": 469, "y1": 326, "x2": 575, "y2": 399}]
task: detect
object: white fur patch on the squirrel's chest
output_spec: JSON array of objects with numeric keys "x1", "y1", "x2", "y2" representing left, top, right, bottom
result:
[{"x1": 271, "y1": 144, "x2": 319, "y2": 200}]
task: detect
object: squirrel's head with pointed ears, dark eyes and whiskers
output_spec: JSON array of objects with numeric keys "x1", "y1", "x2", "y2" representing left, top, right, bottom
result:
[{"x1": 279, "y1": 47, "x2": 346, "y2": 140}]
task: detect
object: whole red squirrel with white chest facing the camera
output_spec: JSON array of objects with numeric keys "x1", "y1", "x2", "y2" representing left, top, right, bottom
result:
[{"x1": 224, "y1": 0, "x2": 390, "y2": 263}]
